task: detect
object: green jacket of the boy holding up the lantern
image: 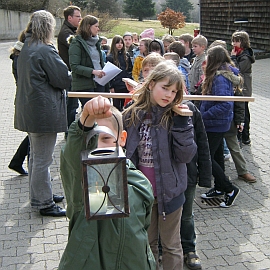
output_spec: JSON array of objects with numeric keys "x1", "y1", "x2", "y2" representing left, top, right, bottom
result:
[{"x1": 59, "y1": 122, "x2": 156, "y2": 270}]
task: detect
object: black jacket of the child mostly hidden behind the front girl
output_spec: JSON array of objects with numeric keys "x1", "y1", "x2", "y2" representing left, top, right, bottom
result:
[{"x1": 184, "y1": 101, "x2": 212, "y2": 187}]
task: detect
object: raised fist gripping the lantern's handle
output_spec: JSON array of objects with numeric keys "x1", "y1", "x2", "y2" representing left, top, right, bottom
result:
[{"x1": 80, "y1": 96, "x2": 112, "y2": 127}]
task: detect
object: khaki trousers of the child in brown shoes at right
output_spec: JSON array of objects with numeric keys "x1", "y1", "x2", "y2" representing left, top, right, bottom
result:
[{"x1": 224, "y1": 133, "x2": 247, "y2": 175}]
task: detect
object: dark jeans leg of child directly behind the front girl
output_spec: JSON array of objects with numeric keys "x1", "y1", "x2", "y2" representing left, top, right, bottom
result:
[{"x1": 180, "y1": 186, "x2": 196, "y2": 254}]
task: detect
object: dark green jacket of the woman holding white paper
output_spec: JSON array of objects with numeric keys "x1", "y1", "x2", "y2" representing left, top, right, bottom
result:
[{"x1": 68, "y1": 35, "x2": 109, "y2": 92}]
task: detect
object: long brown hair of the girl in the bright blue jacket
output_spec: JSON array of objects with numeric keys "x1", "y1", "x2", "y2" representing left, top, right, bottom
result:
[{"x1": 202, "y1": 45, "x2": 234, "y2": 95}]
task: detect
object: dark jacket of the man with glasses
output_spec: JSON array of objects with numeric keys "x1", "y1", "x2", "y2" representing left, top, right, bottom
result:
[{"x1": 57, "y1": 21, "x2": 77, "y2": 70}]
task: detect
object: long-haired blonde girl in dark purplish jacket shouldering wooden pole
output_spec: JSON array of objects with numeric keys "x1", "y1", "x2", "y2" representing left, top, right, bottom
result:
[{"x1": 123, "y1": 61, "x2": 197, "y2": 270}]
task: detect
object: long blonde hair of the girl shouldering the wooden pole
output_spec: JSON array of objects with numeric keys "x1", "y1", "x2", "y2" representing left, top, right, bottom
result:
[{"x1": 123, "y1": 60, "x2": 184, "y2": 127}]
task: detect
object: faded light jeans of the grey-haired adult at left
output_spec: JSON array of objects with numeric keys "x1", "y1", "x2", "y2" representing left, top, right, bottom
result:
[{"x1": 28, "y1": 133, "x2": 57, "y2": 209}]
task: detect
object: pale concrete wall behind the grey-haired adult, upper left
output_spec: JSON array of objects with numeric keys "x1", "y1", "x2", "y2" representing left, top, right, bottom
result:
[{"x1": 0, "y1": 9, "x2": 63, "y2": 40}]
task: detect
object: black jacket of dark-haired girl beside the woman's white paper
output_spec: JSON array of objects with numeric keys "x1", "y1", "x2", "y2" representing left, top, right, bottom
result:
[{"x1": 107, "y1": 51, "x2": 132, "y2": 89}]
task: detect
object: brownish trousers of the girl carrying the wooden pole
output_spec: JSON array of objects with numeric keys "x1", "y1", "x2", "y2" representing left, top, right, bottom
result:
[{"x1": 147, "y1": 201, "x2": 183, "y2": 270}]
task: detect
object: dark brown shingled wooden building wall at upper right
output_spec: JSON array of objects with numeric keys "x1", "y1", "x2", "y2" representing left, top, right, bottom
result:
[{"x1": 200, "y1": 0, "x2": 270, "y2": 52}]
